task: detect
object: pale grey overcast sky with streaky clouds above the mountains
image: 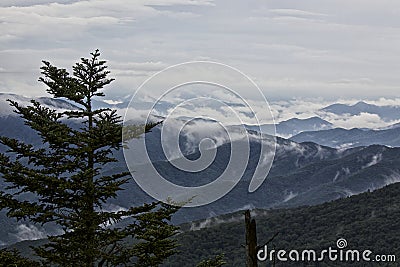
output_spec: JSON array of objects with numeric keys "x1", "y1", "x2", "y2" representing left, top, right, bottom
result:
[{"x1": 0, "y1": 0, "x2": 400, "y2": 99}]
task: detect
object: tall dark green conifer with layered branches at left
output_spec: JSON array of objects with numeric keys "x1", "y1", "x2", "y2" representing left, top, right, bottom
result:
[{"x1": 0, "y1": 50, "x2": 177, "y2": 266}]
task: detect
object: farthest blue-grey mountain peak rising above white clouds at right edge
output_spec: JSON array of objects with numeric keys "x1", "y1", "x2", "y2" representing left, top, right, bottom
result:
[{"x1": 321, "y1": 101, "x2": 400, "y2": 122}]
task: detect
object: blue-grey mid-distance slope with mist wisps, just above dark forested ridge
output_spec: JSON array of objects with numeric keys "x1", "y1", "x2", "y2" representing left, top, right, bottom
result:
[{"x1": 129, "y1": 131, "x2": 400, "y2": 225}]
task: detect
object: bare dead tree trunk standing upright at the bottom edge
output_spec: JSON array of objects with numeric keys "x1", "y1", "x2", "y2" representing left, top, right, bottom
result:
[{"x1": 244, "y1": 210, "x2": 257, "y2": 267}]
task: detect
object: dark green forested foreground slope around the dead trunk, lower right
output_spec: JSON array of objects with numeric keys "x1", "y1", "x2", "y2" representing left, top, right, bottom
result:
[{"x1": 164, "y1": 183, "x2": 400, "y2": 267}]
